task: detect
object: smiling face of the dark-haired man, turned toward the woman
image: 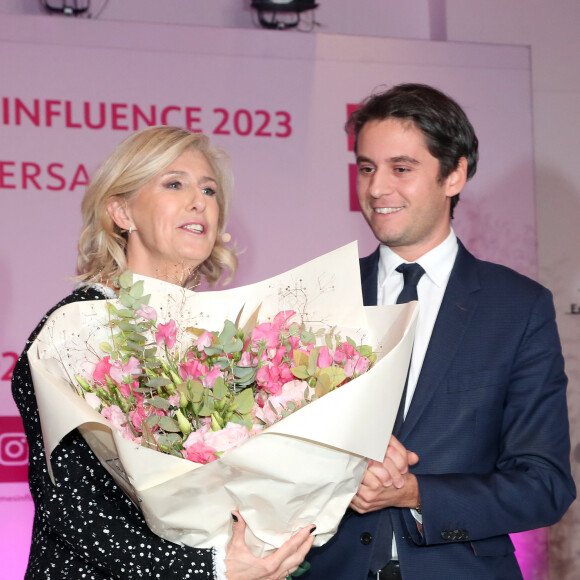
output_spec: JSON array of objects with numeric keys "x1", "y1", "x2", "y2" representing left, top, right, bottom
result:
[{"x1": 357, "y1": 118, "x2": 465, "y2": 261}]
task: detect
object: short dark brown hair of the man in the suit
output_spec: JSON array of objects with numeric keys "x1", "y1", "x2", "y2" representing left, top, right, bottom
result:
[{"x1": 346, "y1": 83, "x2": 478, "y2": 218}]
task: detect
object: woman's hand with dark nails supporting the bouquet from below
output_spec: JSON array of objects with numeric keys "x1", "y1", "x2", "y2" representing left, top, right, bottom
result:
[{"x1": 226, "y1": 511, "x2": 316, "y2": 580}]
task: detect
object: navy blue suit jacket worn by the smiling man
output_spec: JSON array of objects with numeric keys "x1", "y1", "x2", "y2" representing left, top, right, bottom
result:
[{"x1": 302, "y1": 243, "x2": 576, "y2": 580}]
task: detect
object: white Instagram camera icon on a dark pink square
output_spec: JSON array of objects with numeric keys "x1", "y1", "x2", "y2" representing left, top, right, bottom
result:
[{"x1": 0, "y1": 417, "x2": 28, "y2": 482}]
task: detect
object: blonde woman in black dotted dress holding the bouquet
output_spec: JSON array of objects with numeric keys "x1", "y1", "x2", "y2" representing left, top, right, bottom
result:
[{"x1": 12, "y1": 127, "x2": 314, "y2": 580}]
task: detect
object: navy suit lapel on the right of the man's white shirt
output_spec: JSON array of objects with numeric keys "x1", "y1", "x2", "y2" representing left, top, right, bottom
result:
[{"x1": 399, "y1": 242, "x2": 480, "y2": 440}]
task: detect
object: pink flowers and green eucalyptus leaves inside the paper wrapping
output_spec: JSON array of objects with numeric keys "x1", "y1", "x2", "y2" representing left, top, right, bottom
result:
[{"x1": 75, "y1": 271, "x2": 377, "y2": 464}]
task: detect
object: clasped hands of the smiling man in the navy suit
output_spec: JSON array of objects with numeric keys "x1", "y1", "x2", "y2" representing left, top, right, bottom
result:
[{"x1": 350, "y1": 436, "x2": 420, "y2": 514}]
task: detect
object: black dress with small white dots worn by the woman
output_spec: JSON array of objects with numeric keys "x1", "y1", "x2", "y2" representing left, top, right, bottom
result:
[{"x1": 12, "y1": 287, "x2": 218, "y2": 580}]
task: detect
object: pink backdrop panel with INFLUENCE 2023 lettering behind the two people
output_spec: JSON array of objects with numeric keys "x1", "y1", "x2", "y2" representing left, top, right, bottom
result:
[{"x1": 0, "y1": 15, "x2": 547, "y2": 580}]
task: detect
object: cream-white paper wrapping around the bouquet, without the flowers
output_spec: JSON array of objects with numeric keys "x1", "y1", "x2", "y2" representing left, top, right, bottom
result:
[{"x1": 28, "y1": 243, "x2": 418, "y2": 556}]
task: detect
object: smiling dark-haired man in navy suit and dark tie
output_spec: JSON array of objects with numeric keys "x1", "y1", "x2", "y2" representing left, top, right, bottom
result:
[{"x1": 302, "y1": 84, "x2": 576, "y2": 580}]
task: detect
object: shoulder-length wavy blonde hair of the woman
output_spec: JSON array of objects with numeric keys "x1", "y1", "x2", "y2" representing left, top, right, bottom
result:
[{"x1": 77, "y1": 126, "x2": 237, "y2": 287}]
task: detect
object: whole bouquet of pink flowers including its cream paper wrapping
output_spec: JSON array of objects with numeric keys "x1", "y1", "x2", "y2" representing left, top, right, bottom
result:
[{"x1": 28, "y1": 243, "x2": 418, "y2": 555}]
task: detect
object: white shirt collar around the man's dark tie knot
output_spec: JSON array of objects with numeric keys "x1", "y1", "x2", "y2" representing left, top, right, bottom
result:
[{"x1": 378, "y1": 228, "x2": 458, "y2": 287}]
